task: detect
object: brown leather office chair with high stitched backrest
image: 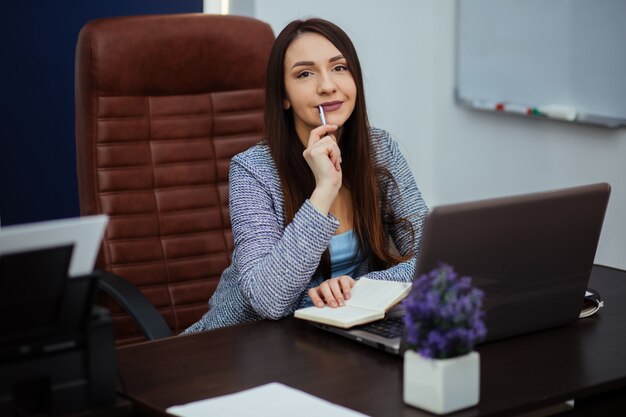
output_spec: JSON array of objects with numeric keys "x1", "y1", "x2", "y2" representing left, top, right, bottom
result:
[{"x1": 75, "y1": 14, "x2": 274, "y2": 344}]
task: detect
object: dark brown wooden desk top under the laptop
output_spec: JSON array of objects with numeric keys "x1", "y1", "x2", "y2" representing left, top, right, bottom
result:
[{"x1": 117, "y1": 267, "x2": 626, "y2": 417}]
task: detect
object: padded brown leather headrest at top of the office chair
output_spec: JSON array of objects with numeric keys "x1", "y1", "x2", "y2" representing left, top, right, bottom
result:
[{"x1": 76, "y1": 14, "x2": 274, "y2": 95}]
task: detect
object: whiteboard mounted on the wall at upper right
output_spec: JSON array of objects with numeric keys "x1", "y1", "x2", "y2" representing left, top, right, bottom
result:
[{"x1": 456, "y1": 0, "x2": 626, "y2": 126}]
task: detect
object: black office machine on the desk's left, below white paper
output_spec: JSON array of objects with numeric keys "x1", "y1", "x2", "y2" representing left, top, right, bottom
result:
[{"x1": 0, "y1": 245, "x2": 115, "y2": 416}]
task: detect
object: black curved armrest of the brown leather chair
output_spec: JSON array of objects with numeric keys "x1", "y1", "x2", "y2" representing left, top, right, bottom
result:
[{"x1": 98, "y1": 271, "x2": 172, "y2": 340}]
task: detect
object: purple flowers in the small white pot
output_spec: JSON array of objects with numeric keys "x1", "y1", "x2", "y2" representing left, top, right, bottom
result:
[{"x1": 403, "y1": 264, "x2": 487, "y2": 359}]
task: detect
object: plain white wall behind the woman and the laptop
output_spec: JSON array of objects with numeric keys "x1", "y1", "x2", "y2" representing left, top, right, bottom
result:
[{"x1": 254, "y1": 0, "x2": 626, "y2": 269}]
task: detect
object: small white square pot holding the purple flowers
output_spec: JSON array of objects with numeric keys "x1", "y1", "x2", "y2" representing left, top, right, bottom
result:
[{"x1": 404, "y1": 350, "x2": 480, "y2": 414}]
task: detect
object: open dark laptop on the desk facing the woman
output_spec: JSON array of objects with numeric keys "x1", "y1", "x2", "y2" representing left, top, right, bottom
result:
[{"x1": 318, "y1": 183, "x2": 611, "y2": 354}]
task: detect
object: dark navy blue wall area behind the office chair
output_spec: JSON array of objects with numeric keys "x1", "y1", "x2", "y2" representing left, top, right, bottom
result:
[{"x1": 0, "y1": 0, "x2": 202, "y2": 225}]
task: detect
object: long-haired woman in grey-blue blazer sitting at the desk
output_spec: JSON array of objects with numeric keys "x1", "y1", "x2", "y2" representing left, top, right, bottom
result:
[{"x1": 186, "y1": 19, "x2": 427, "y2": 333}]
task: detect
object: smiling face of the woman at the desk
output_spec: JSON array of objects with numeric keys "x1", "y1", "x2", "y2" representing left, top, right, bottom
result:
[{"x1": 283, "y1": 33, "x2": 357, "y2": 146}]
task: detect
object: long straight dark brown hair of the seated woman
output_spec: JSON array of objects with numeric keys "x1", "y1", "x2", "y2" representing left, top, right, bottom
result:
[{"x1": 265, "y1": 18, "x2": 411, "y2": 278}]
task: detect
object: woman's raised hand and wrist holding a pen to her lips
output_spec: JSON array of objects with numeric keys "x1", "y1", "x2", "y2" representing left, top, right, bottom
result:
[{"x1": 302, "y1": 124, "x2": 341, "y2": 215}]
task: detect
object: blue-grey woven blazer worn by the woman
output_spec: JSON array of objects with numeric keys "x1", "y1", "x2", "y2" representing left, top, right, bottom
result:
[{"x1": 185, "y1": 128, "x2": 428, "y2": 333}]
